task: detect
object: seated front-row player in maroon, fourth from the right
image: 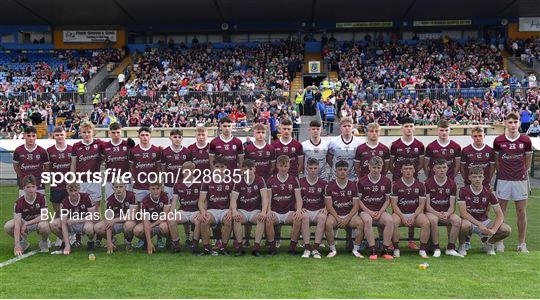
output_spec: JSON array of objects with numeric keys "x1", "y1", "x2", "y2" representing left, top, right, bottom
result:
[{"x1": 357, "y1": 156, "x2": 394, "y2": 260}]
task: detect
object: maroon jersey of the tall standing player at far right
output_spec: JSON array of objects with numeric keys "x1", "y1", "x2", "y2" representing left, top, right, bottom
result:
[{"x1": 493, "y1": 134, "x2": 532, "y2": 181}]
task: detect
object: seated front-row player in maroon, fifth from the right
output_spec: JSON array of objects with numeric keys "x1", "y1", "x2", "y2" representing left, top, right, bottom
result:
[{"x1": 324, "y1": 160, "x2": 364, "y2": 258}]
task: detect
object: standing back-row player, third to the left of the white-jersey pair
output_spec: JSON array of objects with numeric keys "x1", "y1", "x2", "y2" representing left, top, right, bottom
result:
[{"x1": 208, "y1": 117, "x2": 244, "y2": 170}]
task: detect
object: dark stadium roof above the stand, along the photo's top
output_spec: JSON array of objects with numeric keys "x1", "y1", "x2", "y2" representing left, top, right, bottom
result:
[{"x1": 0, "y1": 0, "x2": 540, "y2": 25}]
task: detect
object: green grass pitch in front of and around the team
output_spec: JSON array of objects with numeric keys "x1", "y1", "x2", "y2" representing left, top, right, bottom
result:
[{"x1": 0, "y1": 186, "x2": 540, "y2": 298}]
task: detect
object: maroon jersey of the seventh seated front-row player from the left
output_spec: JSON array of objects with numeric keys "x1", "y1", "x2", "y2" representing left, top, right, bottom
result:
[{"x1": 233, "y1": 175, "x2": 266, "y2": 211}]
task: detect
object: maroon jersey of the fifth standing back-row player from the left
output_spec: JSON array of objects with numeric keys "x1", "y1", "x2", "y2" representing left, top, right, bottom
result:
[{"x1": 129, "y1": 145, "x2": 161, "y2": 190}]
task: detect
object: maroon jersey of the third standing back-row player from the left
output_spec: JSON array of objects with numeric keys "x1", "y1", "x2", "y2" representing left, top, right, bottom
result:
[{"x1": 71, "y1": 139, "x2": 103, "y2": 181}]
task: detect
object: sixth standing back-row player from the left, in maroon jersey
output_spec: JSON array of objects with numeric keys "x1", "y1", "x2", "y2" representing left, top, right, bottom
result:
[{"x1": 161, "y1": 129, "x2": 193, "y2": 199}]
